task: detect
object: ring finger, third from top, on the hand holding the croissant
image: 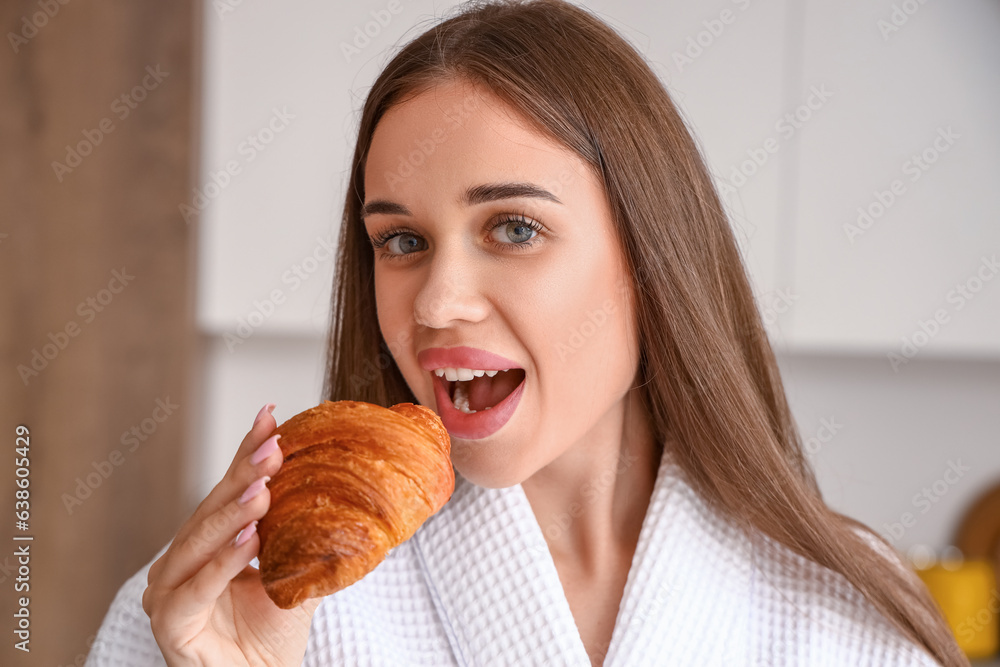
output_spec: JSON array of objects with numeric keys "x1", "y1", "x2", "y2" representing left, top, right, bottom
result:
[{"x1": 157, "y1": 476, "x2": 271, "y2": 590}]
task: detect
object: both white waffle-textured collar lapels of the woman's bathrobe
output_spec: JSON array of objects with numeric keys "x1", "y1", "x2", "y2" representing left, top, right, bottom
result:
[{"x1": 411, "y1": 450, "x2": 752, "y2": 667}]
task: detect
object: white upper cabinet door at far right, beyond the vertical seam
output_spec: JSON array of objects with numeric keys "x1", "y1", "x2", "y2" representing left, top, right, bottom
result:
[{"x1": 779, "y1": 0, "x2": 1000, "y2": 360}]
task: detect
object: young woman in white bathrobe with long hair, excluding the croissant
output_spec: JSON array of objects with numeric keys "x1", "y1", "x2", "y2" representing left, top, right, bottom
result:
[{"x1": 91, "y1": 0, "x2": 968, "y2": 666}]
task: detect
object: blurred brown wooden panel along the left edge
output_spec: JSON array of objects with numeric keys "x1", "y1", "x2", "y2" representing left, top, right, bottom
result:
[{"x1": 0, "y1": 0, "x2": 197, "y2": 665}]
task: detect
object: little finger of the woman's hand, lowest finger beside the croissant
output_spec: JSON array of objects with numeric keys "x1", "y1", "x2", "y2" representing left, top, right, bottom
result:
[{"x1": 169, "y1": 521, "x2": 260, "y2": 618}]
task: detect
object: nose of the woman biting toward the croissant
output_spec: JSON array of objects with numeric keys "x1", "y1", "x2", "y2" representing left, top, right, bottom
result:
[{"x1": 413, "y1": 253, "x2": 489, "y2": 329}]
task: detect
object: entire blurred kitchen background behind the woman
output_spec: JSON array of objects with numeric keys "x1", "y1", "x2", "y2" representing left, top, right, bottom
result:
[{"x1": 0, "y1": 0, "x2": 1000, "y2": 665}]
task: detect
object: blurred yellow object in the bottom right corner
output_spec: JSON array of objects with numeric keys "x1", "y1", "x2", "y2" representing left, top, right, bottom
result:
[{"x1": 916, "y1": 559, "x2": 1000, "y2": 659}]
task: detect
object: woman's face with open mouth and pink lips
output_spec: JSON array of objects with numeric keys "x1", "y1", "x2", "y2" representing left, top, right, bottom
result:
[{"x1": 364, "y1": 82, "x2": 639, "y2": 488}]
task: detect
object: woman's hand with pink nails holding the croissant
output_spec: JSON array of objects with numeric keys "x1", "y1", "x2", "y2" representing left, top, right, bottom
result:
[{"x1": 142, "y1": 404, "x2": 321, "y2": 667}]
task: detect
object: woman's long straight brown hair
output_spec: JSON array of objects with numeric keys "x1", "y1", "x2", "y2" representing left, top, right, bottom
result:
[{"x1": 323, "y1": 0, "x2": 968, "y2": 667}]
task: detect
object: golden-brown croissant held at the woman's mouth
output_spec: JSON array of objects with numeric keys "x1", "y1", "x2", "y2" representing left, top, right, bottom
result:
[{"x1": 257, "y1": 401, "x2": 455, "y2": 609}]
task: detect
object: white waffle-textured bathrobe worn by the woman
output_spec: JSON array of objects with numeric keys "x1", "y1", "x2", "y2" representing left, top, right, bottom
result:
[{"x1": 86, "y1": 456, "x2": 939, "y2": 667}]
